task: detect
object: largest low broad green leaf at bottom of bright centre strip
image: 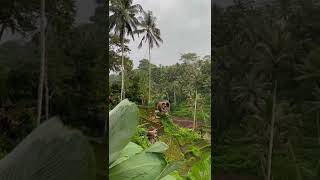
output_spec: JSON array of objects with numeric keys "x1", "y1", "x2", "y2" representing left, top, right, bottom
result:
[{"x1": 109, "y1": 152, "x2": 166, "y2": 180}]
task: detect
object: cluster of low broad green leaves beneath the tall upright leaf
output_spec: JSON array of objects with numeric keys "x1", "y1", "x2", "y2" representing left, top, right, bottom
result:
[{"x1": 109, "y1": 141, "x2": 177, "y2": 180}]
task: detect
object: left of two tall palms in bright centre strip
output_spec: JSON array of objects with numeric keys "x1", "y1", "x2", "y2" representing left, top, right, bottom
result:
[{"x1": 109, "y1": 0, "x2": 143, "y2": 100}]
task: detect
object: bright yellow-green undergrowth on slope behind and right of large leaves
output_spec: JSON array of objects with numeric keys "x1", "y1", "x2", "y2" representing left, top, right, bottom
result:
[{"x1": 132, "y1": 108, "x2": 211, "y2": 180}]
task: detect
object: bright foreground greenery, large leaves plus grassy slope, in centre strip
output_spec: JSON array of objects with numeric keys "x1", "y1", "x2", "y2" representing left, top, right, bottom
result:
[{"x1": 109, "y1": 100, "x2": 211, "y2": 180}]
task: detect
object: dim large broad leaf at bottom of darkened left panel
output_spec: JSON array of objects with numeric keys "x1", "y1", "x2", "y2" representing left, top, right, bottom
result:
[{"x1": 0, "y1": 118, "x2": 96, "y2": 180}]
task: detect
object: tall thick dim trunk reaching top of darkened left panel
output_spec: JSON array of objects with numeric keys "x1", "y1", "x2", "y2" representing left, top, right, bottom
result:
[{"x1": 36, "y1": 0, "x2": 45, "y2": 126}]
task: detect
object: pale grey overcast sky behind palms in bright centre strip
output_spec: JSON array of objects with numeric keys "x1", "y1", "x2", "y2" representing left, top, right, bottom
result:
[{"x1": 129, "y1": 0, "x2": 211, "y2": 67}]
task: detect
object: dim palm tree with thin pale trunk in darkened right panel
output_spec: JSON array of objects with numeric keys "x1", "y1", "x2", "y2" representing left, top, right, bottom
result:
[{"x1": 252, "y1": 19, "x2": 292, "y2": 180}]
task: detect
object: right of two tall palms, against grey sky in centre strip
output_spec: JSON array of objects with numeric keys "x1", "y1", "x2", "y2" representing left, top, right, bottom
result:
[{"x1": 136, "y1": 11, "x2": 163, "y2": 103}]
